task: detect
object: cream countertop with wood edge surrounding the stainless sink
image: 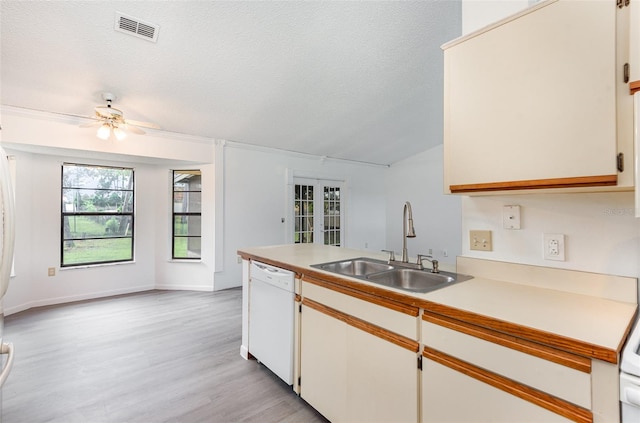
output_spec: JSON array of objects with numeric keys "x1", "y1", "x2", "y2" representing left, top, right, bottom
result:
[{"x1": 239, "y1": 244, "x2": 637, "y2": 362}]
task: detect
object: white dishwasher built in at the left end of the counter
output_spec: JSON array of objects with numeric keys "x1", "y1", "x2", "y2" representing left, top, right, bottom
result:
[{"x1": 249, "y1": 261, "x2": 295, "y2": 385}]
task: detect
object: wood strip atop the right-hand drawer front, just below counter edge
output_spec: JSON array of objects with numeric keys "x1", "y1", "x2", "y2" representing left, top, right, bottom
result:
[{"x1": 422, "y1": 311, "x2": 591, "y2": 373}]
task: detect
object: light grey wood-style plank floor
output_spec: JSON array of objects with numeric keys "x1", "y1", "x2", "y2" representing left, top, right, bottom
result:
[{"x1": 2, "y1": 289, "x2": 326, "y2": 423}]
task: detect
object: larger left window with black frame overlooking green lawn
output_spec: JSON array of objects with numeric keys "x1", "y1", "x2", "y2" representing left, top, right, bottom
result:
[{"x1": 60, "y1": 163, "x2": 134, "y2": 267}]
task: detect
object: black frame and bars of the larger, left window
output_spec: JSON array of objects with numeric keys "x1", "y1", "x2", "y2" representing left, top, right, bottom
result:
[{"x1": 60, "y1": 162, "x2": 136, "y2": 268}]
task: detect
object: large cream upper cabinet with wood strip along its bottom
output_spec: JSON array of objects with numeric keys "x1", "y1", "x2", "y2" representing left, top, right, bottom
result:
[{"x1": 443, "y1": 0, "x2": 634, "y2": 194}]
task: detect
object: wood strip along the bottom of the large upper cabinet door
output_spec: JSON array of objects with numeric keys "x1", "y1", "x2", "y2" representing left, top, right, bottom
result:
[{"x1": 449, "y1": 175, "x2": 618, "y2": 194}]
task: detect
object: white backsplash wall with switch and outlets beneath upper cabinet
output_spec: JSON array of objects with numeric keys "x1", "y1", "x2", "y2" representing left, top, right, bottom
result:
[{"x1": 462, "y1": 193, "x2": 640, "y2": 277}]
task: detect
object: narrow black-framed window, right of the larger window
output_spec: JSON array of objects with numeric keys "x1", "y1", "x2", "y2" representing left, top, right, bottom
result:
[{"x1": 172, "y1": 170, "x2": 202, "y2": 259}]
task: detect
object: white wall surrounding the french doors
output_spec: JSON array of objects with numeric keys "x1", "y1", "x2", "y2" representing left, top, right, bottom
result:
[{"x1": 215, "y1": 143, "x2": 388, "y2": 290}]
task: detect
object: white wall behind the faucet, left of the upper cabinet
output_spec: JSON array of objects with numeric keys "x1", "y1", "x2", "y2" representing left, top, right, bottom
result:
[{"x1": 386, "y1": 144, "x2": 462, "y2": 263}]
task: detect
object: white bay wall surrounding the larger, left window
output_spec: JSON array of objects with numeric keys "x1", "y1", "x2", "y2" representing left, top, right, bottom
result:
[{"x1": 4, "y1": 149, "x2": 158, "y2": 314}]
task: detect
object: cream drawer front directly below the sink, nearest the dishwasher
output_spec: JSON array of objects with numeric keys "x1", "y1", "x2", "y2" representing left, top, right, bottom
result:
[{"x1": 301, "y1": 280, "x2": 418, "y2": 340}]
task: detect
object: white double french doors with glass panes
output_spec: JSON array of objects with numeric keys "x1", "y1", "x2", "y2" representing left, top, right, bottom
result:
[{"x1": 293, "y1": 178, "x2": 344, "y2": 247}]
